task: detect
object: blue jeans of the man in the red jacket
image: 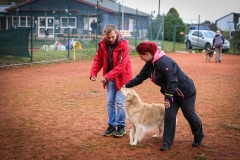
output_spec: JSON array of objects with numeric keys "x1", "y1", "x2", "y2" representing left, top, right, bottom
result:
[{"x1": 107, "y1": 80, "x2": 126, "y2": 127}]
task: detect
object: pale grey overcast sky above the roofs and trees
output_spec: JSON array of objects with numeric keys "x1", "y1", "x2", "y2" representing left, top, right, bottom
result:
[{"x1": 117, "y1": 0, "x2": 240, "y2": 23}]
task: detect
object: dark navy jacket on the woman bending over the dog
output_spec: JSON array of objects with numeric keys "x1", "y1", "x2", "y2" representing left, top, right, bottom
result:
[{"x1": 125, "y1": 51, "x2": 196, "y2": 100}]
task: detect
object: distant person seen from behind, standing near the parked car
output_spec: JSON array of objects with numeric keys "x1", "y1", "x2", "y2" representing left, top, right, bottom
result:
[{"x1": 213, "y1": 30, "x2": 225, "y2": 63}]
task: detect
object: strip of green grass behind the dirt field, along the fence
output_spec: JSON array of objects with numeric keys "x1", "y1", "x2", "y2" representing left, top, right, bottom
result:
[{"x1": 0, "y1": 38, "x2": 191, "y2": 66}]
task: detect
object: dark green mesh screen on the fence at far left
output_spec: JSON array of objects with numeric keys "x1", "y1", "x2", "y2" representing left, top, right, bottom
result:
[{"x1": 0, "y1": 28, "x2": 30, "y2": 57}]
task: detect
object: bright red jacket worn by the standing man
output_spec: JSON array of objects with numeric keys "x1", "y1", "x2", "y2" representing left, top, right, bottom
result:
[{"x1": 90, "y1": 34, "x2": 132, "y2": 90}]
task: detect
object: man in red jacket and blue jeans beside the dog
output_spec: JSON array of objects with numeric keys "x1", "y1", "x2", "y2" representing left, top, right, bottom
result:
[{"x1": 90, "y1": 24, "x2": 132, "y2": 137}]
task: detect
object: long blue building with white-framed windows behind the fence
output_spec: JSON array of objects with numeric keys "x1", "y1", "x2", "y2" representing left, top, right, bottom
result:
[{"x1": 3, "y1": 0, "x2": 151, "y2": 37}]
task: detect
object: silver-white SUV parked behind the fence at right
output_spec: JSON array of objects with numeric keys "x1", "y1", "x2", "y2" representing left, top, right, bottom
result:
[{"x1": 184, "y1": 30, "x2": 230, "y2": 52}]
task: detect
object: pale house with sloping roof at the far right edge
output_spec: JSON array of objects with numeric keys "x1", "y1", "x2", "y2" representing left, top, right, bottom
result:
[{"x1": 215, "y1": 12, "x2": 240, "y2": 31}]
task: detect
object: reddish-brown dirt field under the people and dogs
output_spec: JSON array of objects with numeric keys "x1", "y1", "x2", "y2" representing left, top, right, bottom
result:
[{"x1": 0, "y1": 53, "x2": 240, "y2": 160}]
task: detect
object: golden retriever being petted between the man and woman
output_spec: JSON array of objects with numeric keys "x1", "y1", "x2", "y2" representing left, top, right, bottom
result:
[{"x1": 121, "y1": 87, "x2": 165, "y2": 145}]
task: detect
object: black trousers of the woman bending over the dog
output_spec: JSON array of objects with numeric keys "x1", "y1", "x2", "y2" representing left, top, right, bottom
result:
[{"x1": 163, "y1": 94, "x2": 204, "y2": 145}]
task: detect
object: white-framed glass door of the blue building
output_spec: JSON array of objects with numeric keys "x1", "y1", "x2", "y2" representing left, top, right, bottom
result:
[{"x1": 37, "y1": 17, "x2": 54, "y2": 38}]
